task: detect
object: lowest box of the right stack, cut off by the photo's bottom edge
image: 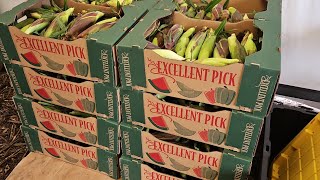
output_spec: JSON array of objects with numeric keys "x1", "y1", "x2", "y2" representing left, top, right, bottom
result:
[{"x1": 120, "y1": 156, "x2": 182, "y2": 180}]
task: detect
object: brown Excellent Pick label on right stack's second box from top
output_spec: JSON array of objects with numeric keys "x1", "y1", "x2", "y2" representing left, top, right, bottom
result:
[{"x1": 141, "y1": 93, "x2": 231, "y2": 148}]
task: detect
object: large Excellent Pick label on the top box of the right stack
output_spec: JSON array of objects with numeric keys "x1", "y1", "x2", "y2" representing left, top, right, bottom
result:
[{"x1": 144, "y1": 50, "x2": 244, "y2": 109}]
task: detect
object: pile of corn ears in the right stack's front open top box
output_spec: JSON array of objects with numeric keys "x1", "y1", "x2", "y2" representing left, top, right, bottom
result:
[{"x1": 147, "y1": 20, "x2": 257, "y2": 66}]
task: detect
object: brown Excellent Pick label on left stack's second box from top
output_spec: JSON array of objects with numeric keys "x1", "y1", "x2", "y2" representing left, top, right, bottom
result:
[{"x1": 24, "y1": 68, "x2": 96, "y2": 114}]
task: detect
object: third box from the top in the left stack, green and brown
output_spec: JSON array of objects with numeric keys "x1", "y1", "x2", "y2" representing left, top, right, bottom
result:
[{"x1": 13, "y1": 96, "x2": 120, "y2": 154}]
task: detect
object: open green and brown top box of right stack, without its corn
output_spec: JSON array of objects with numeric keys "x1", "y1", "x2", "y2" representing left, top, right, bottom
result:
[{"x1": 117, "y1": 0, "x2": 281, "y2": 117}]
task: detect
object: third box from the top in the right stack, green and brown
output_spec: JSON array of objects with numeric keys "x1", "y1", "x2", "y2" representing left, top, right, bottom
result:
[{"x1": 121, "y1": 123, "x2": 252, "y2": 179}]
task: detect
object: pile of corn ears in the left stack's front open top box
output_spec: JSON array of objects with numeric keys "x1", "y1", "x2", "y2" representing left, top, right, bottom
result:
[{"x1": 16, "y1": 6, "x2": 118, "y2": 40}]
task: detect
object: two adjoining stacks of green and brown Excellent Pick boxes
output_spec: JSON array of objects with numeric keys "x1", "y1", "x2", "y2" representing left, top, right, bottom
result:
[{"x1": 0, "y1": 0, "x2": 281, "y2": 180}]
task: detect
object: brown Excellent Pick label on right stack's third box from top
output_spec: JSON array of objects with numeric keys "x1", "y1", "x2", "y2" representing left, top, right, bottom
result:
[{"x1": 141, "y1": 131, "x2": 223, "y2": 179}]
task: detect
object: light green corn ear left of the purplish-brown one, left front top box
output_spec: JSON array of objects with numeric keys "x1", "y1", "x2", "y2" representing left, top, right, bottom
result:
[{"x1": 44, "y1": 8, "x2": 74, "y2": 37}]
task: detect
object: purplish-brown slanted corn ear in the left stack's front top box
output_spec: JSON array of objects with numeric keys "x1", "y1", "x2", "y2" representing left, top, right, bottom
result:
[{"x1": 66, "y1": 11, "x2": 104, "y2": 39}]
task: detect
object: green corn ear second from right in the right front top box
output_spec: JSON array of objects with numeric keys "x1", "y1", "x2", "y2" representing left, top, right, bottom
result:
[{"x1": 228, "y1": 34, "x2": 246, "y2": 63}]
